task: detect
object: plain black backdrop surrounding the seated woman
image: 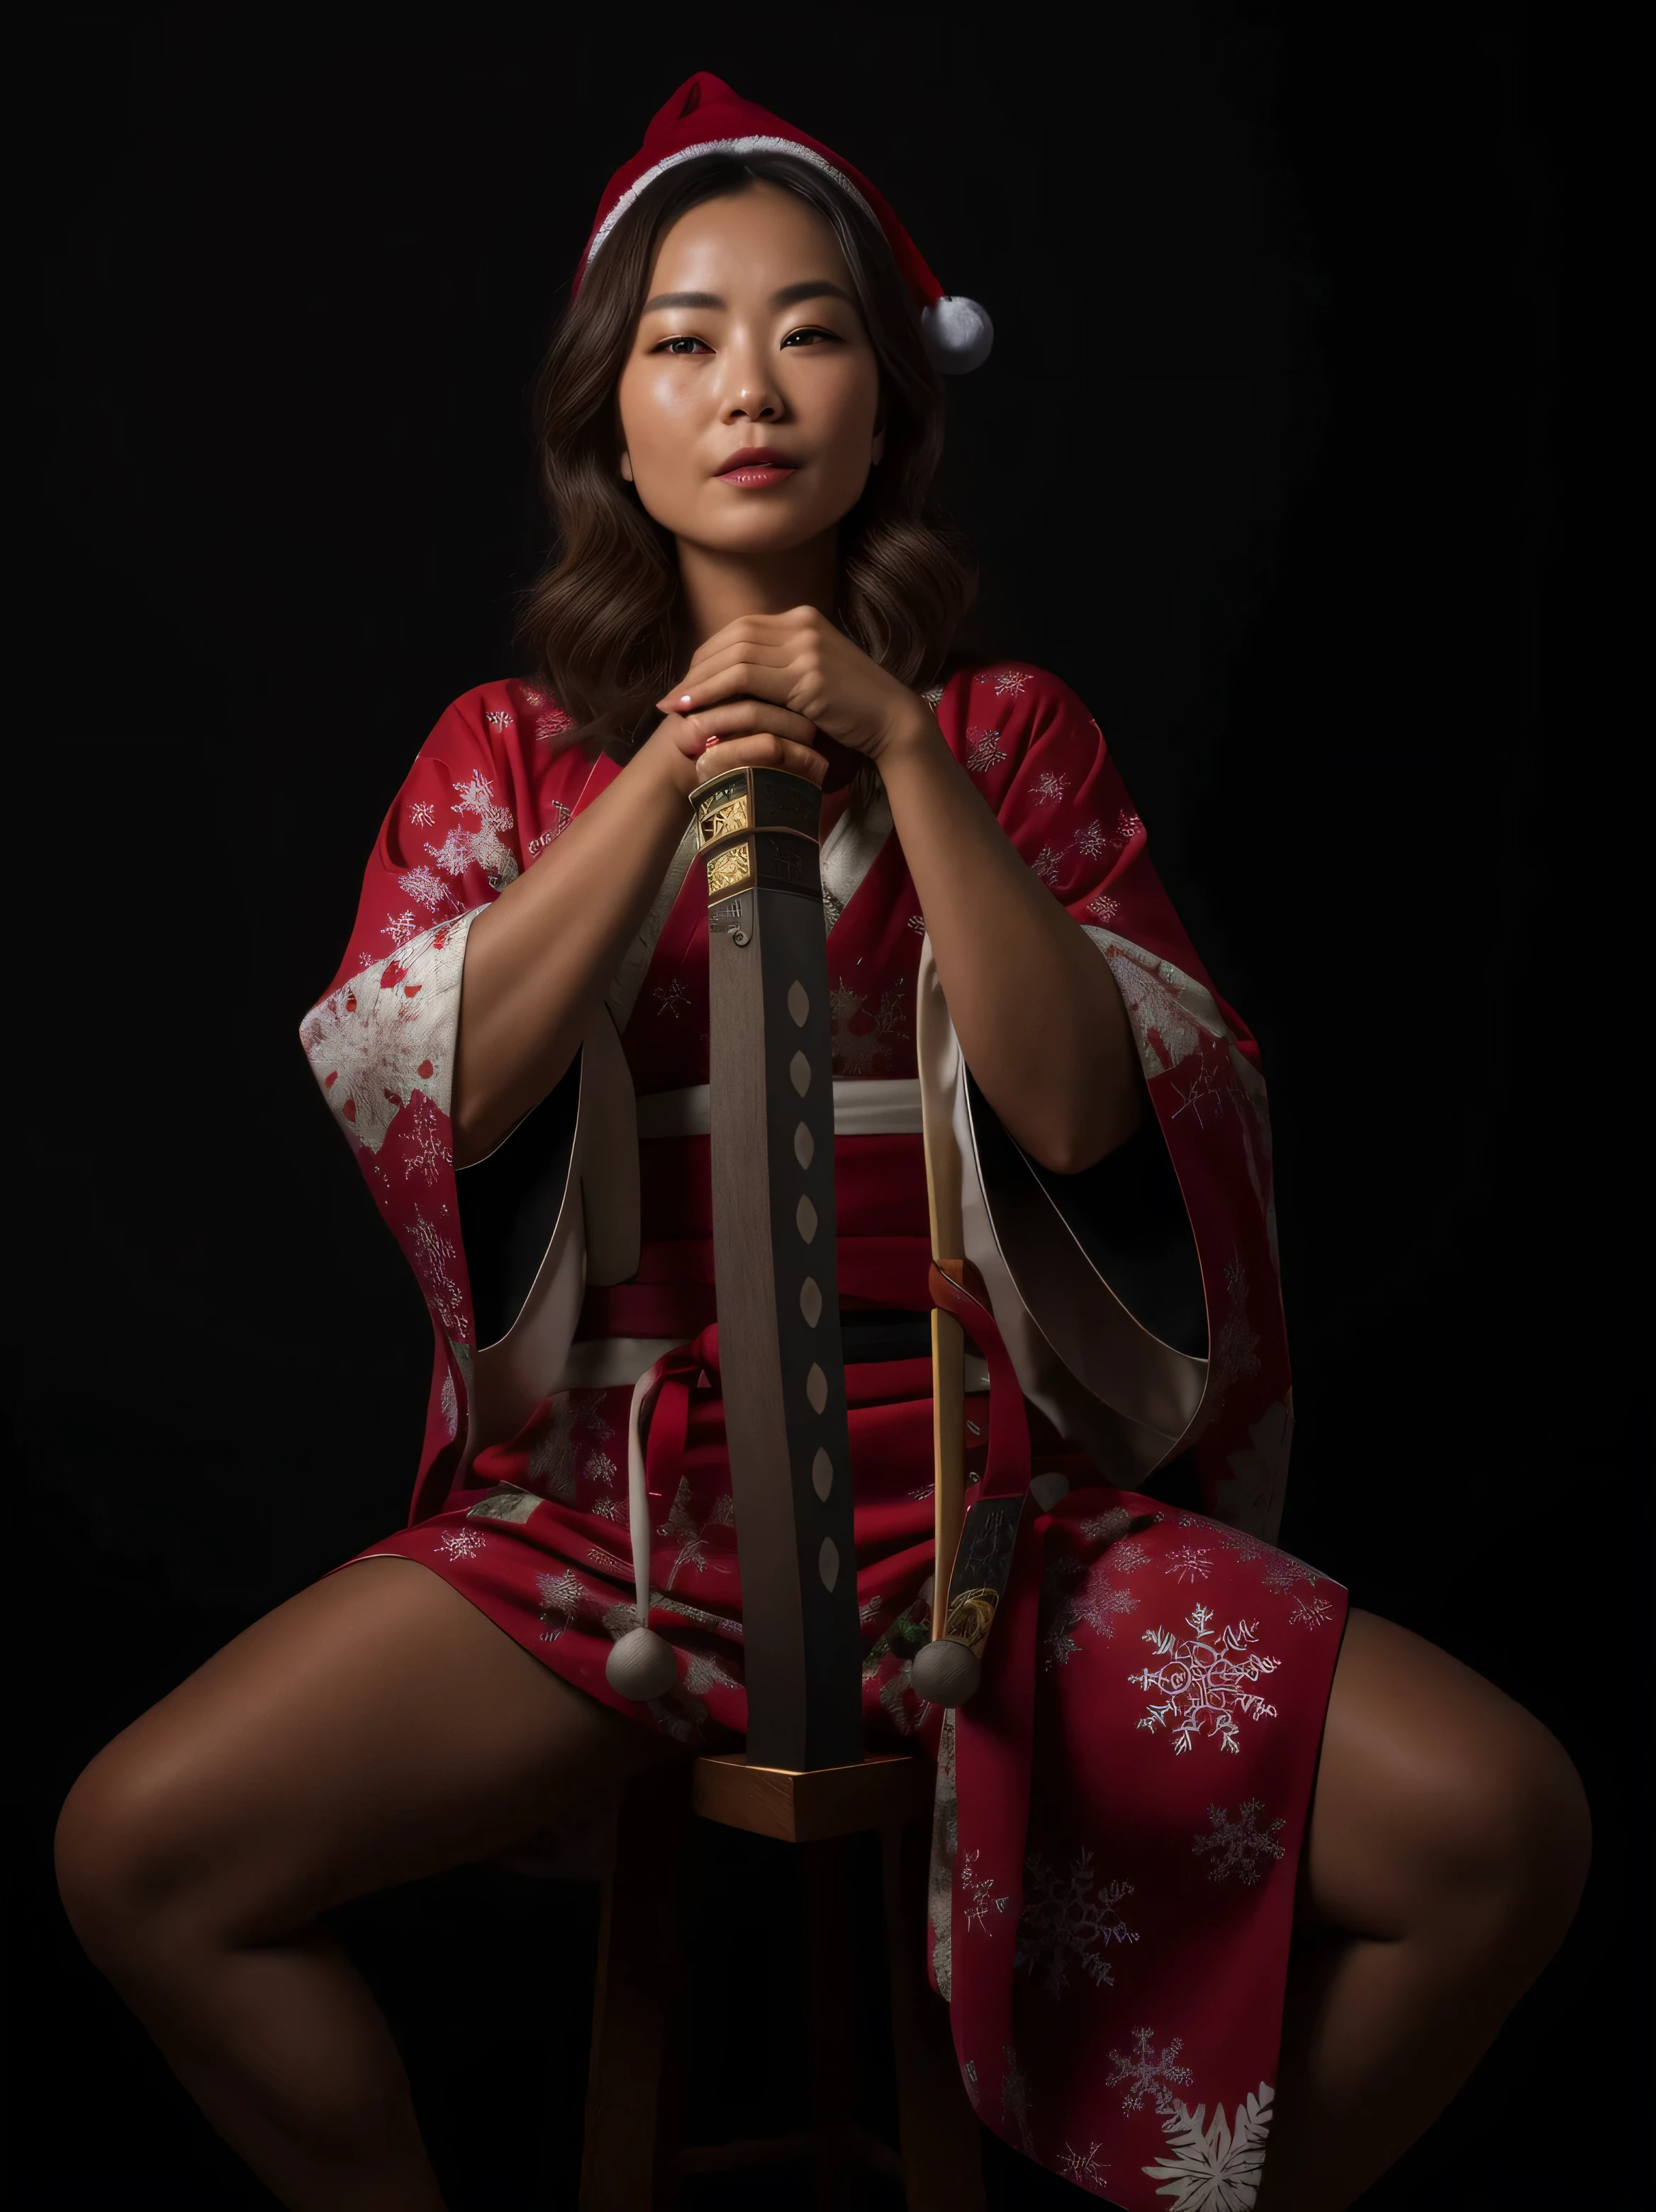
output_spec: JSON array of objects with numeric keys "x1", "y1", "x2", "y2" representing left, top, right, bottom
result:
[{"x1": 6, "y1": 4, "x2": 1647, "y2": 2212}]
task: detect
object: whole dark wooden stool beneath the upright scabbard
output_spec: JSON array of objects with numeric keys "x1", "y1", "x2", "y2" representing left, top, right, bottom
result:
[{"x1": 581, "y1": 1752, "x2": 984, "y2": 2212}]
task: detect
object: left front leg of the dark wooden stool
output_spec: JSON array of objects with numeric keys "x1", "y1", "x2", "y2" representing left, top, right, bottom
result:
[{"x1": 579, "y1": 1765, "x2": 690, "y2": 2212}]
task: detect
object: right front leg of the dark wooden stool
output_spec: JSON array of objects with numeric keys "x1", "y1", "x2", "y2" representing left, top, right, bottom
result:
[{"x1": 880, "y1": 1821, "x2": 984, "y2": 2212}]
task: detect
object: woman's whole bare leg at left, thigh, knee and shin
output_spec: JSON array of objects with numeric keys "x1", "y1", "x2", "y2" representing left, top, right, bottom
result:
[{"x1": 57, "y1": 1560, "x2": 672, "y2": 2212}]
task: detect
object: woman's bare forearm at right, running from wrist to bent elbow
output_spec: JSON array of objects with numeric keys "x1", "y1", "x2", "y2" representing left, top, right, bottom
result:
[{"x1": 880, "y1": 715, "x2": 1143, "y2": 1175}]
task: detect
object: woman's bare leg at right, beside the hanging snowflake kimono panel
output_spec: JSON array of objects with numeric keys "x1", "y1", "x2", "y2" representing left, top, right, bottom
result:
[{"x1": 1260, "y1": 1612, "x2": 1589, "y2": 2212}]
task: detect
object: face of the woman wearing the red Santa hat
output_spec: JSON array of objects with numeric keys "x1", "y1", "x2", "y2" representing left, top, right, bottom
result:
[{"x1": 617, "y1": 184, "x2": 882, "y2": 555}]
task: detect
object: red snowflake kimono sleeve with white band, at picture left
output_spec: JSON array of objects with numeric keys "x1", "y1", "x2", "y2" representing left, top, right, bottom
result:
[{"x1": 298, "y1": 686, "x2": 532, "y2": 1515}]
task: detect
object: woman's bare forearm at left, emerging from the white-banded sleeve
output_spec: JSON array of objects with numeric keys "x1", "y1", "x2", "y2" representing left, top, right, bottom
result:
[{"x1": 453, "y1": 732, "x2": 694, "y2": 1166}]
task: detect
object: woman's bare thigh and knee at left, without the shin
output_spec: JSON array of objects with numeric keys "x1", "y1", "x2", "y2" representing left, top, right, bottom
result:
[{"x1": 57, "y1": 1560, "x2": 674, "y2": 1942}]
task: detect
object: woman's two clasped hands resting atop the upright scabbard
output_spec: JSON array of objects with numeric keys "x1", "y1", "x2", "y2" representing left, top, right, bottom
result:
[{"x1": 656, "y1": 606, "x2": 931, "y2": 786}]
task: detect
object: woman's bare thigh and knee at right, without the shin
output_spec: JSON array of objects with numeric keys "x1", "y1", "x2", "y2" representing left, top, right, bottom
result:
[{"x1": 1302, "y1": 1608, "x2": 1587, "y2": 1938}]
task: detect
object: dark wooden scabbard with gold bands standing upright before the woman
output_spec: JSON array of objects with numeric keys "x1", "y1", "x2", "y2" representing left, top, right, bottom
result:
[{"x1": 696, "y1": 768, "x2": 862, "y2": 1772}]
